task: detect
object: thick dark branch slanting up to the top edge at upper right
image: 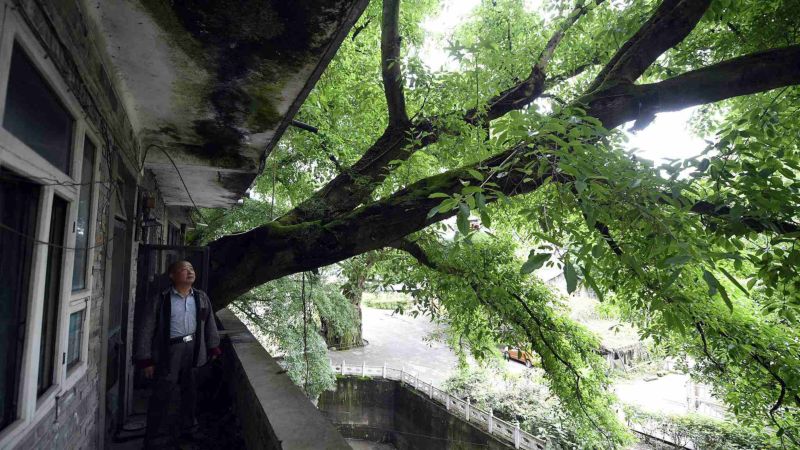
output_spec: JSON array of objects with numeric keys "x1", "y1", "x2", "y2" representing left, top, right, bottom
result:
[{"x1": 587, "y1": 0, "x2": 711, "y2": 92}]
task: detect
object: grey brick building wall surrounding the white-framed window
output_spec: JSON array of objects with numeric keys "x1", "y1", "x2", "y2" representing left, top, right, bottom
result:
[{"x1": 0, "y1": 0, "x2": 153, "y2": 449}]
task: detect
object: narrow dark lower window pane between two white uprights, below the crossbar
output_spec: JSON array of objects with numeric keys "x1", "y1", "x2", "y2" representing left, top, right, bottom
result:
[{"x1": 37, "y1": 196, "x2": 68, "y2": 395}]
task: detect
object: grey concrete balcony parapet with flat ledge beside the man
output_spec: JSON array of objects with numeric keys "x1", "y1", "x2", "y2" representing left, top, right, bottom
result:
[{"x1": 217, "y1": 309, "x2": 350, "y2": 450}]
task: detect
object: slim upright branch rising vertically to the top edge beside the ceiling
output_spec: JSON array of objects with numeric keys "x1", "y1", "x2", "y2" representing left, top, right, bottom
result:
[{"x1": 381, "y1": 0, "x2": 409, "y2": 128}]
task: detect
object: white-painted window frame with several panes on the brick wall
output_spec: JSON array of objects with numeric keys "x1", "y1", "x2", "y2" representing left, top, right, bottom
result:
[{"x1": 0, "y1": 8, "x2": 103, "y2": 448}]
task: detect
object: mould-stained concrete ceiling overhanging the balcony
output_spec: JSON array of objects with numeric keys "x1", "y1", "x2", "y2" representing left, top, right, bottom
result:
[{"x1": 91, "y1": 0, "x2": 368, "y2": 207}]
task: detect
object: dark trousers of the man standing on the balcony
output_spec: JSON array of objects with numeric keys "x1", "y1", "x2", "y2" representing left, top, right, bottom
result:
[{"x1": 145, "y1": 341, "x2": 197, "y2": 442}]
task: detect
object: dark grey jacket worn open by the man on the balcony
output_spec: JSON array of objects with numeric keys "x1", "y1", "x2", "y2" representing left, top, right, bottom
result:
[{"x1": 136, "y1": 287, "x2": 221, "y2": 368}]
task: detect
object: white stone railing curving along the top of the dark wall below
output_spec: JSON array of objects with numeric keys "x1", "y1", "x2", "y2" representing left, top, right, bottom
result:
[{"x1": 331, "y1": 361, "x2": 550, "y2": 450}]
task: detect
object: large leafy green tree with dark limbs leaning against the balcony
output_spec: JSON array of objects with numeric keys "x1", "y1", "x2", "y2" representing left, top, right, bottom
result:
[{"x1": 194, "y1": 0, "x2": 800, "y2": 447}]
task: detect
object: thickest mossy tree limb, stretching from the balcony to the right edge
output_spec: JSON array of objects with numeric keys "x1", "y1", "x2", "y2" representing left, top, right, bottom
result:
[{"x1": 217, "y1": 46, "x2": 800, "y2": 307}]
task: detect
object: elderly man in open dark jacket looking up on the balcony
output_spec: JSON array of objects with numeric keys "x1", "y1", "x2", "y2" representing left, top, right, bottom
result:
[{"x1": 136, "y1": 261, "x2": 220, "y2": 448}]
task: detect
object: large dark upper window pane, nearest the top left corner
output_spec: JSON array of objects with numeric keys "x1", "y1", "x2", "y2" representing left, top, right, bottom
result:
[{"x1": 3, "y1": 43, "x2": 74, "y2": 174}]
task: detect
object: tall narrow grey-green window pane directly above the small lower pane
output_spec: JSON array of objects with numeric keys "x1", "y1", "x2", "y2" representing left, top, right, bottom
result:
[{"x1": 72, "y1": 137, "x2": 95, "y2": 291}]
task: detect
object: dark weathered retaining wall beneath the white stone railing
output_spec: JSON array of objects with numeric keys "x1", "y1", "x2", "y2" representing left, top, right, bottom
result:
[{"x1": 319, "y1": 377, "x2": 509, "y2": 450}]
